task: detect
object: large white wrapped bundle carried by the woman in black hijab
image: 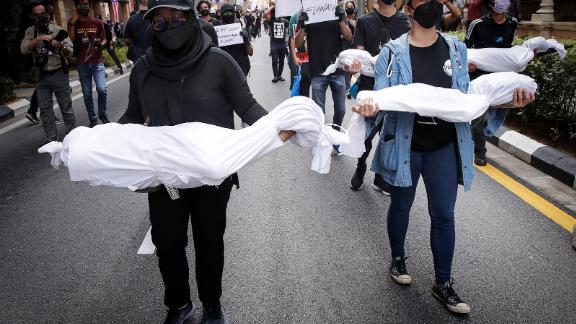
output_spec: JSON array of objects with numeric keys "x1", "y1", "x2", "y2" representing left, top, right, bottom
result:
[{"x1": 38, "y1": 97, "x2": 357, "y2": 190}]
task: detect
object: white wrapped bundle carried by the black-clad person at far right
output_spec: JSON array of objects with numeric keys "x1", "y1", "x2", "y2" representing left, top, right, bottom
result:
[{"x1": 468, "y1": 37, "x2": 566, "y2": 72}]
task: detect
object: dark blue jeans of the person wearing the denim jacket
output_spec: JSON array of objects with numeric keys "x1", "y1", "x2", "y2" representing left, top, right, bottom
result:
[{"x1": 388, "y1": 143, "x2": 458, "y2": 283}]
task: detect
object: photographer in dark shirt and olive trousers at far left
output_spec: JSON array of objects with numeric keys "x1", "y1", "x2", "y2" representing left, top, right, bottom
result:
[{"x1": 20, "y1": 3, "x2": 75, "y2": 142}]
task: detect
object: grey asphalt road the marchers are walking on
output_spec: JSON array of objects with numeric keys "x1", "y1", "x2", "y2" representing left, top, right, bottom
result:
[{"x1": 0, "y1": 36, "x2": 576, "y2": 323}]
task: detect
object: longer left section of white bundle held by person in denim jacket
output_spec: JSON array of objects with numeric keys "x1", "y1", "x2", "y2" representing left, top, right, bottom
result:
[{"x1": 356, "y1": 83, "x2": 489, "y2": 122}]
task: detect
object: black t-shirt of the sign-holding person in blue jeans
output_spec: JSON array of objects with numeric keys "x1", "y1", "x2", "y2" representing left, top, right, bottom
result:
[{"x1": 306, "y1": 20, "x2": 344, "y2": 77}]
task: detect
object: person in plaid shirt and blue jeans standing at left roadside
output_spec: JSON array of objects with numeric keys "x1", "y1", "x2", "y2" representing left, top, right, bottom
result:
[{"x1": 68, "y1": 0, "x2": 109, "y2": 127}]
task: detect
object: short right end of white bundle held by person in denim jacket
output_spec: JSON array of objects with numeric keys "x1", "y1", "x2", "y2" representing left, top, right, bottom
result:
[{"x1": 468, "y1": 72, "x2": 538, "y2": 107}]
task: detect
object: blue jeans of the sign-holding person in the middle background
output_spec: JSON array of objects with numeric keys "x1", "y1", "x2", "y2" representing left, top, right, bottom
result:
[{"x1": 312, "y1": 74, "x2": 346, "y2": 125}]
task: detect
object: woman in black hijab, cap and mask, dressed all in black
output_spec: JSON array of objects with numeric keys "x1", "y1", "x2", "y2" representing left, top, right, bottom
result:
[{"x1": 120, "y1": 0, "x2": 293, "y2": 323}]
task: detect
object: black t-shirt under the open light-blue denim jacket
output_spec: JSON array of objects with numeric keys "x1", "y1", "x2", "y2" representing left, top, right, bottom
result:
[{"x1": 410, "y1": 36, "x2": 456, "y2": 152}]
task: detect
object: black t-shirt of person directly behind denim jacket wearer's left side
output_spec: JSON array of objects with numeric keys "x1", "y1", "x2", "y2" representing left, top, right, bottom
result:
[{"x1": 352, "y1": 10, "x2": 410, "y2": 90}]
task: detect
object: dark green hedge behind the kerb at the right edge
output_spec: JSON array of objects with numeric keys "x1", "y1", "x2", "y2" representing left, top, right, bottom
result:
[{"x1": 516, "y1": 40, "x2": 576, "y2": 141}]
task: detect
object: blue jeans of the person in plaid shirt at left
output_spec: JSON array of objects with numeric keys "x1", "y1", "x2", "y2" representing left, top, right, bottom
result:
[{"x1": 77, "y1": 63, "x2": 108, "y2": 121}]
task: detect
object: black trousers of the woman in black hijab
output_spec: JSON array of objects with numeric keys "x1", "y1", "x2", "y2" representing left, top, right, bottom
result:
[{"x1": 148, "y1": 178, "x2": 232, "y2": 308}]
